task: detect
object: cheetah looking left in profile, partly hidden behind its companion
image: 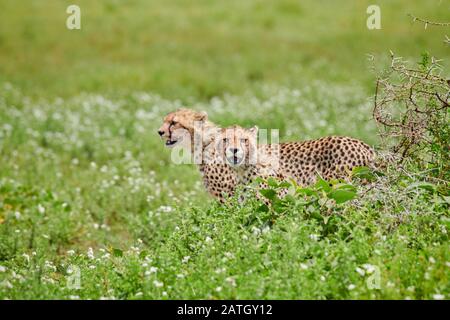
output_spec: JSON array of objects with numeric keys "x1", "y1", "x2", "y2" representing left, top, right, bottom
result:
[{"x1": 158, "y1": 108, "x2": 237, "y2": 203}]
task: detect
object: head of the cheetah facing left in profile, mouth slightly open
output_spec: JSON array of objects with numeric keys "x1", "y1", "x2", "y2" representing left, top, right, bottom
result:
[{"x1": 158, "y1": 108, "x2": 208, "y2": 147}]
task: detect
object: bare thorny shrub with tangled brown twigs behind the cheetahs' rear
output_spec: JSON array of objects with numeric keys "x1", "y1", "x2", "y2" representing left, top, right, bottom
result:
[{"x1": 373, "y1": 53, "x2": 450, "y2": 178}]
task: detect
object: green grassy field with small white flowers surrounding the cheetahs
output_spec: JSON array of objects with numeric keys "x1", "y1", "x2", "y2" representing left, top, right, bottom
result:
[{"x1": 0, "y1": 0, "x2": 450, "y2": 299}]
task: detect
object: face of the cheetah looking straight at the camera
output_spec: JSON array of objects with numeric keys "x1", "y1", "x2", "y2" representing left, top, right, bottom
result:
[{"x1": 218, "y1": 126, "x2": 258, "y2": 168}]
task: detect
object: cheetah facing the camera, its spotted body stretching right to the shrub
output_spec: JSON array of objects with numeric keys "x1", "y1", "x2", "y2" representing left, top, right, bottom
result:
[{"x1": 216, "y1": 126, "x2": 374, "y2": 190}]
